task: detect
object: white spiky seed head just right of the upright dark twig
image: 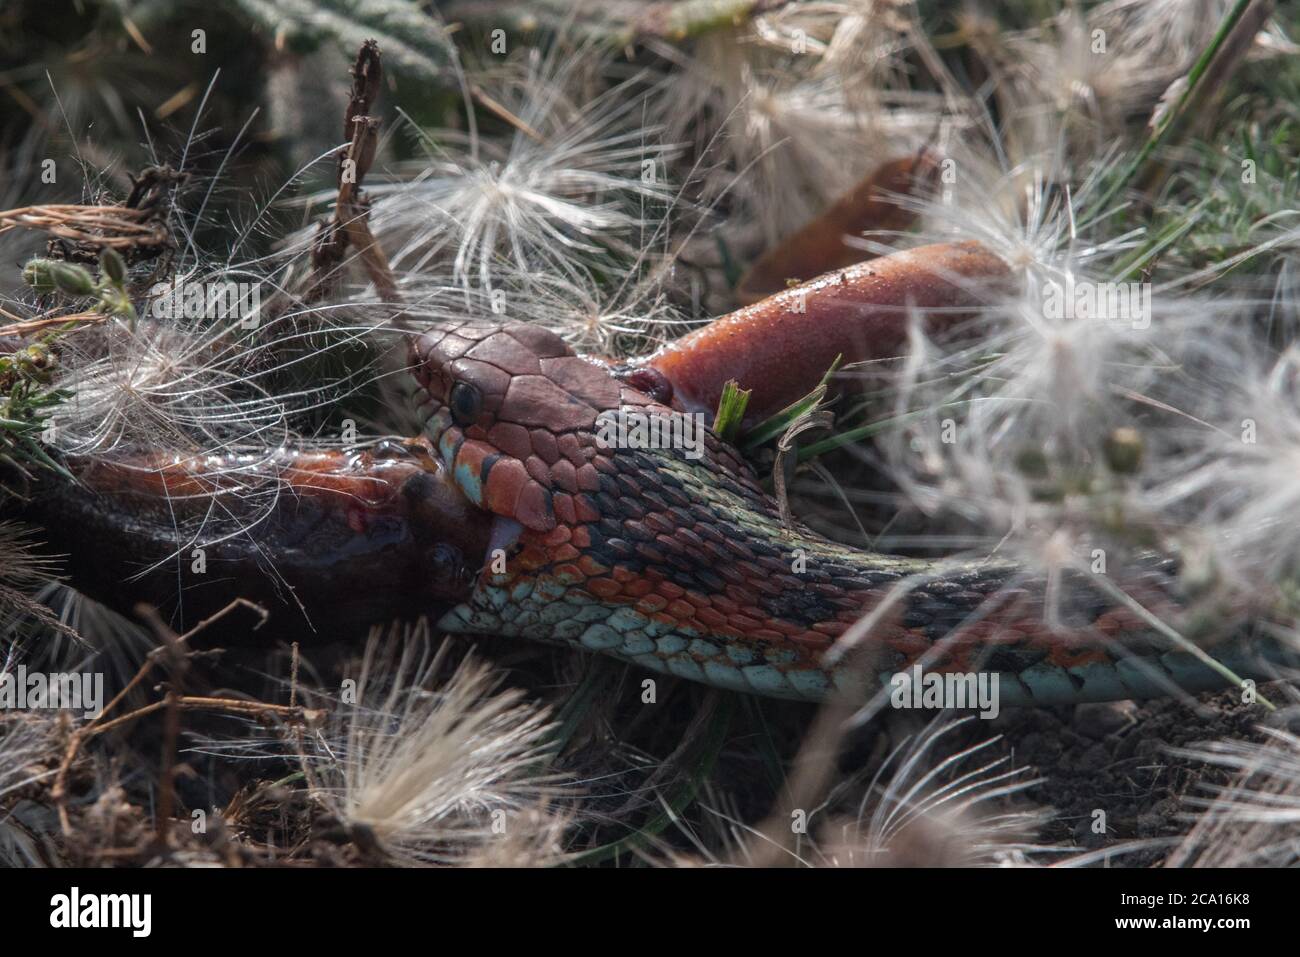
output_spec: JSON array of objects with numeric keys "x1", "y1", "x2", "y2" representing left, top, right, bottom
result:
[{"x1": 368, "y1": 42, "x2": 676, "y2": 289}]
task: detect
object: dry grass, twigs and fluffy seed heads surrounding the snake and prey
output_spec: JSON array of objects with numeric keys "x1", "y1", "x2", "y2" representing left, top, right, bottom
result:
[{"x1": 0, "y1": 0, "x2": 1300, "y2": 867}]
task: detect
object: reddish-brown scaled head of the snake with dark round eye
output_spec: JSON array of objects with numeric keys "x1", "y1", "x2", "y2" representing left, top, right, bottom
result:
[{"x1": 410, "y1": 321, "x2": 624, "y2": 532}]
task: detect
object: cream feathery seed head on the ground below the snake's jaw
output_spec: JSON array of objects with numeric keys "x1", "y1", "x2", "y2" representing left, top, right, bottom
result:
[{"x1": 307, "y1": 628, "x2": 569, "y2": 865}]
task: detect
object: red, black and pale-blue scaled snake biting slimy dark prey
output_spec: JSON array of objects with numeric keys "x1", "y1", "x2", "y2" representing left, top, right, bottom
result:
[{"x1": 411, "y1": 321, "x2": 1289, "y2": 705}]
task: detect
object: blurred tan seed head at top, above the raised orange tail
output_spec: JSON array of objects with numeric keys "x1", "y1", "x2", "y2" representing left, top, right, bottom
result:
[{"x1": 653, "y1": 17, "x2": 943, "y2": 246}]
